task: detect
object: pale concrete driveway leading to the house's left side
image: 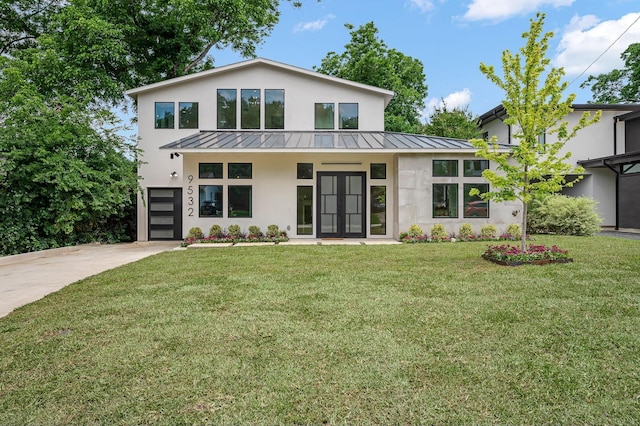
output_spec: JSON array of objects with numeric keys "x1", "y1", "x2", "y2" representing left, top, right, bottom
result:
[{"x1": 0, "y1": 241, "x2": 180, "y2": 317}]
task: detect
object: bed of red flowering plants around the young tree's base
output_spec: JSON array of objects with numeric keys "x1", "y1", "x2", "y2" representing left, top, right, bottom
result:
[{"x1": 482, "y1": 244, "x2": 571, "y2": 264}]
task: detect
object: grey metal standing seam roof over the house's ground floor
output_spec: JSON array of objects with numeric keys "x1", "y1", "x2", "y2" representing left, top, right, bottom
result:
[{"x1": 160, "y1": 130, "x2": 502, "y2": 151}]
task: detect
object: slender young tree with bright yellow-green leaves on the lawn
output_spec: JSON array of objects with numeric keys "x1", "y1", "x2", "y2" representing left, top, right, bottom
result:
[{"x1": 470, "y1": 13, "x2": 601, "y2": 251}]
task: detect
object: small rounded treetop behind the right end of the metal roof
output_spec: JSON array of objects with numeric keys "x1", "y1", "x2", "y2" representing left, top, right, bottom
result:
[{"x1": 421, "y1": 102, "x2": 480, "y2": 139}]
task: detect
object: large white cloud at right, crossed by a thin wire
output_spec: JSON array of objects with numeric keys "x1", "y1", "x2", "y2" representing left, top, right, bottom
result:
[{"x1": 554, "y1": 12, "x2": 640, "y2": 76}]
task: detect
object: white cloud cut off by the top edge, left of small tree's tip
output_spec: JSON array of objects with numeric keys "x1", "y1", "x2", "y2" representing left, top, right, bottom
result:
[{"x1": 462, "y1": 0, "x2": 575, "y2": 21}]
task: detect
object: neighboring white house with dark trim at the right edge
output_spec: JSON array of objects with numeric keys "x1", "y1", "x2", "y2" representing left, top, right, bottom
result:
[{"x1": 478, "y1": 104, "x2": 640, "y2": 229}]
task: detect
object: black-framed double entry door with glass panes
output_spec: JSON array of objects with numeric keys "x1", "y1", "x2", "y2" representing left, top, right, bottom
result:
[{"x1": 316, "y1": 172, "x2": 366, "y2": 238}]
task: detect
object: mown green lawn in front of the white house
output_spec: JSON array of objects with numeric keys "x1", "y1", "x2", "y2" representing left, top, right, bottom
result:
[{"x1": 0, "y1": 236, "x2": 640, "y2": 425}]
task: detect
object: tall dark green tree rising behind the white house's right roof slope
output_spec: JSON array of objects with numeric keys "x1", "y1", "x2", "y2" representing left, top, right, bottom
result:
[{"x1": 314, "y1": 22, "x2": 428, "y2": 132}]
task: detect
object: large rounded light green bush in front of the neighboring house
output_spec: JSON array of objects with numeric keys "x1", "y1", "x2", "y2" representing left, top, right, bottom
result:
[{"x1": 528, "y1": 194, "x2": 601, "y2": 235}]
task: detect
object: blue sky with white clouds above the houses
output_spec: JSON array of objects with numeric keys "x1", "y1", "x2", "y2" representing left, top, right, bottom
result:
[{"x1": 211, "y1": 0, "x2": 640, "y2": 121}]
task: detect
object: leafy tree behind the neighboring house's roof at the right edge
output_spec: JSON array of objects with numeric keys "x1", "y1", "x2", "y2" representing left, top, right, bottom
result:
[{"x1": 580, "y1": 43, "x2": 640, "y2": 104}]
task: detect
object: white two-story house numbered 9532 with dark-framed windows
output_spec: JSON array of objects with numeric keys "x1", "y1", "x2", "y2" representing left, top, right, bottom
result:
[{"x1": 127, "y1": 58, "x2": 519, "y2": 241}]
